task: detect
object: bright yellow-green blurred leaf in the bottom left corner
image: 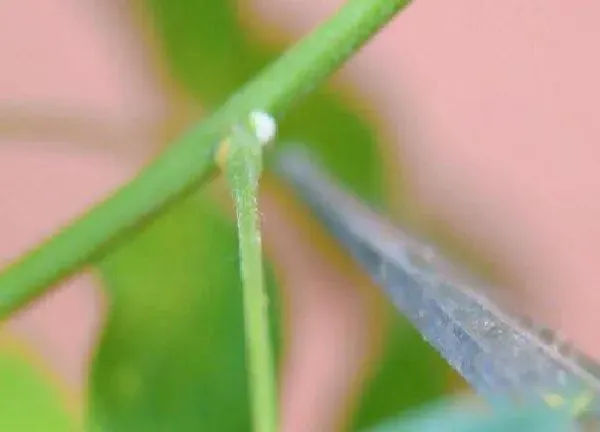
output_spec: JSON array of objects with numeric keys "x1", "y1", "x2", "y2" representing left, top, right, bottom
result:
[{"x1": 0, "y1": 347, "x2": 77, "y2": 432}]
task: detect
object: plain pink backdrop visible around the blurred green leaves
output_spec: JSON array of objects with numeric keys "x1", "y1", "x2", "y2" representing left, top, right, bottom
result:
[{"x1": 0, "y1": 0, "x2": 600, "y2": 430}]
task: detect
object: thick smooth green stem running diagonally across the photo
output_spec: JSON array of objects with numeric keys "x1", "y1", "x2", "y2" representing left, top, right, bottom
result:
[{"x1": 0, "y1": 0, "x2": 408, "y2": 319}]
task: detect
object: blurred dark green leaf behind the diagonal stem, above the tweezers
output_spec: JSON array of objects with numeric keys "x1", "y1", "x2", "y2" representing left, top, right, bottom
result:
[{"x1": 147, "y1": 0, "x2": 383, "y2": 205}]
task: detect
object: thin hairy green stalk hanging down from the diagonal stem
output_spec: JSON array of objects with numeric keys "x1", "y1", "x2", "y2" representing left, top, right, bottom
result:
[{"x1": 225, "y1": 120, "x2": 277, "y2": 432}]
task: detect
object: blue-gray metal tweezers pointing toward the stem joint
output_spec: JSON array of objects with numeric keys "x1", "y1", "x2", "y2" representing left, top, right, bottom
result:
[{"x1": 275, "y1": 149, "x2": 600, "y2": 422}]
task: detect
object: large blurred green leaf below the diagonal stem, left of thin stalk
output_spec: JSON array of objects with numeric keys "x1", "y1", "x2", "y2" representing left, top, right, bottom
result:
[{"x1": 90, "y1": 199, "x2": 278, "y2": 432}]
